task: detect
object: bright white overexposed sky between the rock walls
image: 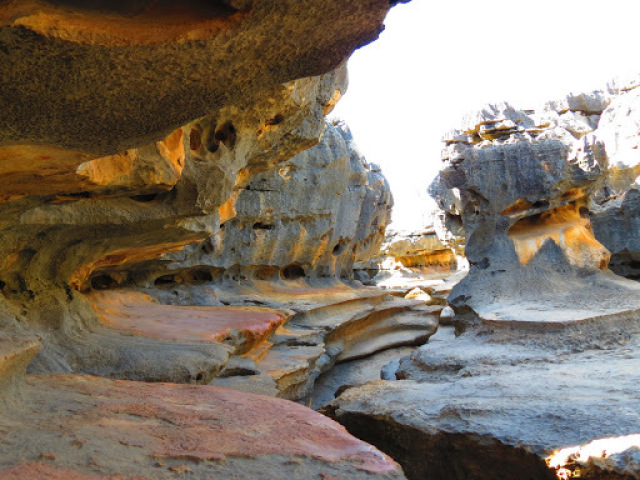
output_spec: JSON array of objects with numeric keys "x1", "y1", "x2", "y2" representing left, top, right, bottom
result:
[{"x1": 334, "y1": 0, "x2": 640, "y2": 229}]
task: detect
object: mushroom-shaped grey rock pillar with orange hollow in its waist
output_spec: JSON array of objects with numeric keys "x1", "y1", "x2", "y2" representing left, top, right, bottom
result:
[{"x1": 431, "y1": 92, "x2": 640, "y2": 328}]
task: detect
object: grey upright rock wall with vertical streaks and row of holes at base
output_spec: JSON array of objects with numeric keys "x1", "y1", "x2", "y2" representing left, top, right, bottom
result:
[{"x1": 101, "y1": 123, "x2": 393, "y2": 285}]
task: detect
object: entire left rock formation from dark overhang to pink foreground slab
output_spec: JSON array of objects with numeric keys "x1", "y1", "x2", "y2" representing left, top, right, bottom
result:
[{"x1": 0, "y1": 0, "x2": 420, "y2": 479}]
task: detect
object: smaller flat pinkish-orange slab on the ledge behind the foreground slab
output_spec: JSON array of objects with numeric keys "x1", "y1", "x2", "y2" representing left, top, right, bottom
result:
[{"x1": 90, "y1": 291, "x2": 286, "y2": 353}]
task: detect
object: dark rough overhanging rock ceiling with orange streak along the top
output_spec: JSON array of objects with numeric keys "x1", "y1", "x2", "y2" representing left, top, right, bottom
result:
[{"x1": 0, "y1": 0, "x2": 397, "y2": 154}]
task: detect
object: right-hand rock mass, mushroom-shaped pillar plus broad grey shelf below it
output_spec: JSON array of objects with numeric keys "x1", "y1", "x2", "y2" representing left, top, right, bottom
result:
[{"x1": 324, "y1": 81, "x2": 640, "y2": 479}]
